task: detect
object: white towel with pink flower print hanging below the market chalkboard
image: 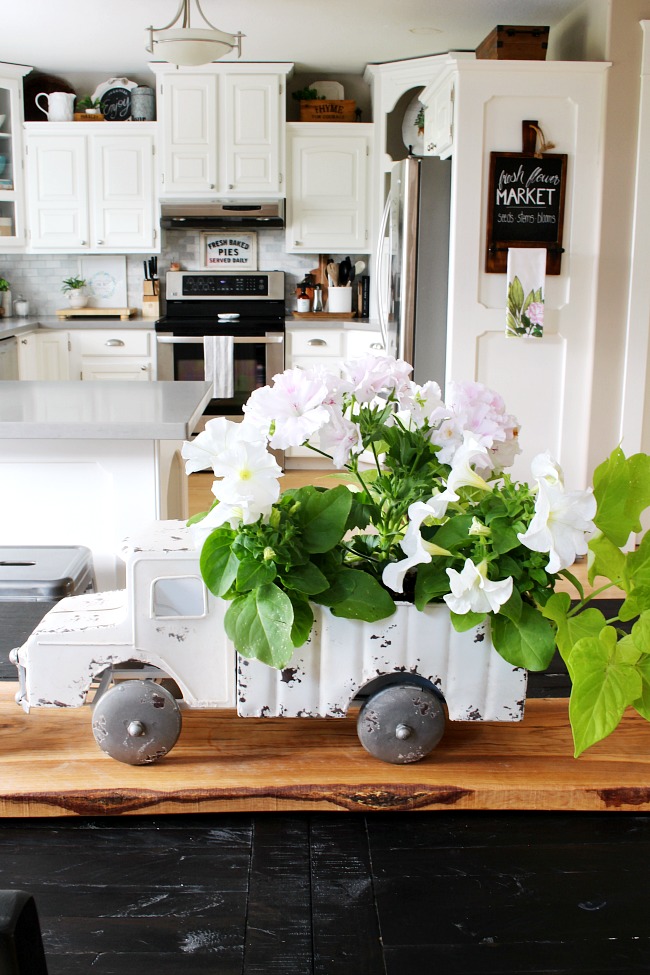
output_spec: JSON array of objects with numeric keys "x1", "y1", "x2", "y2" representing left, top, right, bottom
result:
[{"x1": 506, "y1": 247, "x2": 546, "y2": 339}]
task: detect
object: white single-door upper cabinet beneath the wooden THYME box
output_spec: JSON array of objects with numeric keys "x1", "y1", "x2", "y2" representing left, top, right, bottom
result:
[{"x1": 286, "y1": 122, "x2": 372, "y2": 254}]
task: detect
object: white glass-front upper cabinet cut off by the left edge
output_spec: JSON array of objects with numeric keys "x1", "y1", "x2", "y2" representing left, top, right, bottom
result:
[{"x1": 0, "y1": 64, "x2": 31, "y2": 253}]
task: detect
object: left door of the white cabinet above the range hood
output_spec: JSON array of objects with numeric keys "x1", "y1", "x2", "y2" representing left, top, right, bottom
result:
[{"x1": 160, "y1": 74, "x2": 217, "y2": 193}]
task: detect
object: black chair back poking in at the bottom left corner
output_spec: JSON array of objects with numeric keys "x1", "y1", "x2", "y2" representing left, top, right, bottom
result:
[{"x1": 0, "y1": 890, "x2": 47, "y2": 975}]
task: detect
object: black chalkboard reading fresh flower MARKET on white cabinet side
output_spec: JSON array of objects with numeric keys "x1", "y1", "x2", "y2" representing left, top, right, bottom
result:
[{"x1": 485, "y1": 152, "x2": 567, "y2": 274}]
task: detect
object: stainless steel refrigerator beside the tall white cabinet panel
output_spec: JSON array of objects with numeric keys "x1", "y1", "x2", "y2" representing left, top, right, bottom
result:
[{"x1": 375, "y1": 156, "x2": 451, "y2": 393}]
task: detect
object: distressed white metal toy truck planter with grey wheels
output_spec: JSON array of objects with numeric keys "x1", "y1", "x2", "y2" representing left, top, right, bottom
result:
[{"x1": 11, "y1": 522, "x2": 527, "y2": 765}]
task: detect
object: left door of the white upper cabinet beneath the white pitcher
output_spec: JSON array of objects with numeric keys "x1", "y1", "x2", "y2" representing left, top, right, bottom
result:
[{"x1": 27, "y1": 135, "x2": 89, "y2": 250}]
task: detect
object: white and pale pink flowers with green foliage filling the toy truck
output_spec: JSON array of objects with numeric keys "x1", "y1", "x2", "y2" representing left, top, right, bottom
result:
[{"x1": 183, "y1": 356, "x2": 650, "y2": 756}]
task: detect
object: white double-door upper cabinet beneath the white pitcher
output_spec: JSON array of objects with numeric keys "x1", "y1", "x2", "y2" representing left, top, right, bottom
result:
[{"x1": 25, "y1": 122, "x2": 160, "y2": 253}]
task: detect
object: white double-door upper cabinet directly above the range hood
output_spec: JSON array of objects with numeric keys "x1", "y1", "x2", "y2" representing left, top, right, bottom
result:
[{"x1": 151, "y1": 64, "x2": 293, "y2": 198}]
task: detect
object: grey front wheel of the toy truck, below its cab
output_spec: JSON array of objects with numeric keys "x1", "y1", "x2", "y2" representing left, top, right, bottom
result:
[{"x1": 93, "y1": 680, "x2": 181, "y2": 765}]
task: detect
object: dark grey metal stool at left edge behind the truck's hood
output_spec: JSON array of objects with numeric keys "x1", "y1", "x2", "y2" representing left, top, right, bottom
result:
[{"x1": 0, "y1": 545, "x2": 96, "y2": 680}]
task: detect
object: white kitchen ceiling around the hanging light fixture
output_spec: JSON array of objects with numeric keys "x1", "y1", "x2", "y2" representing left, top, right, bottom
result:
[{"x1": 0, "y1": 0, "x2": 581, "y2": 86}]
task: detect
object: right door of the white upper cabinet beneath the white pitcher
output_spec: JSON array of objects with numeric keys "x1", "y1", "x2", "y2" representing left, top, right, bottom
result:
[{"x1": 90, "y1": 135, "x2": 155, "y2": 251}]
